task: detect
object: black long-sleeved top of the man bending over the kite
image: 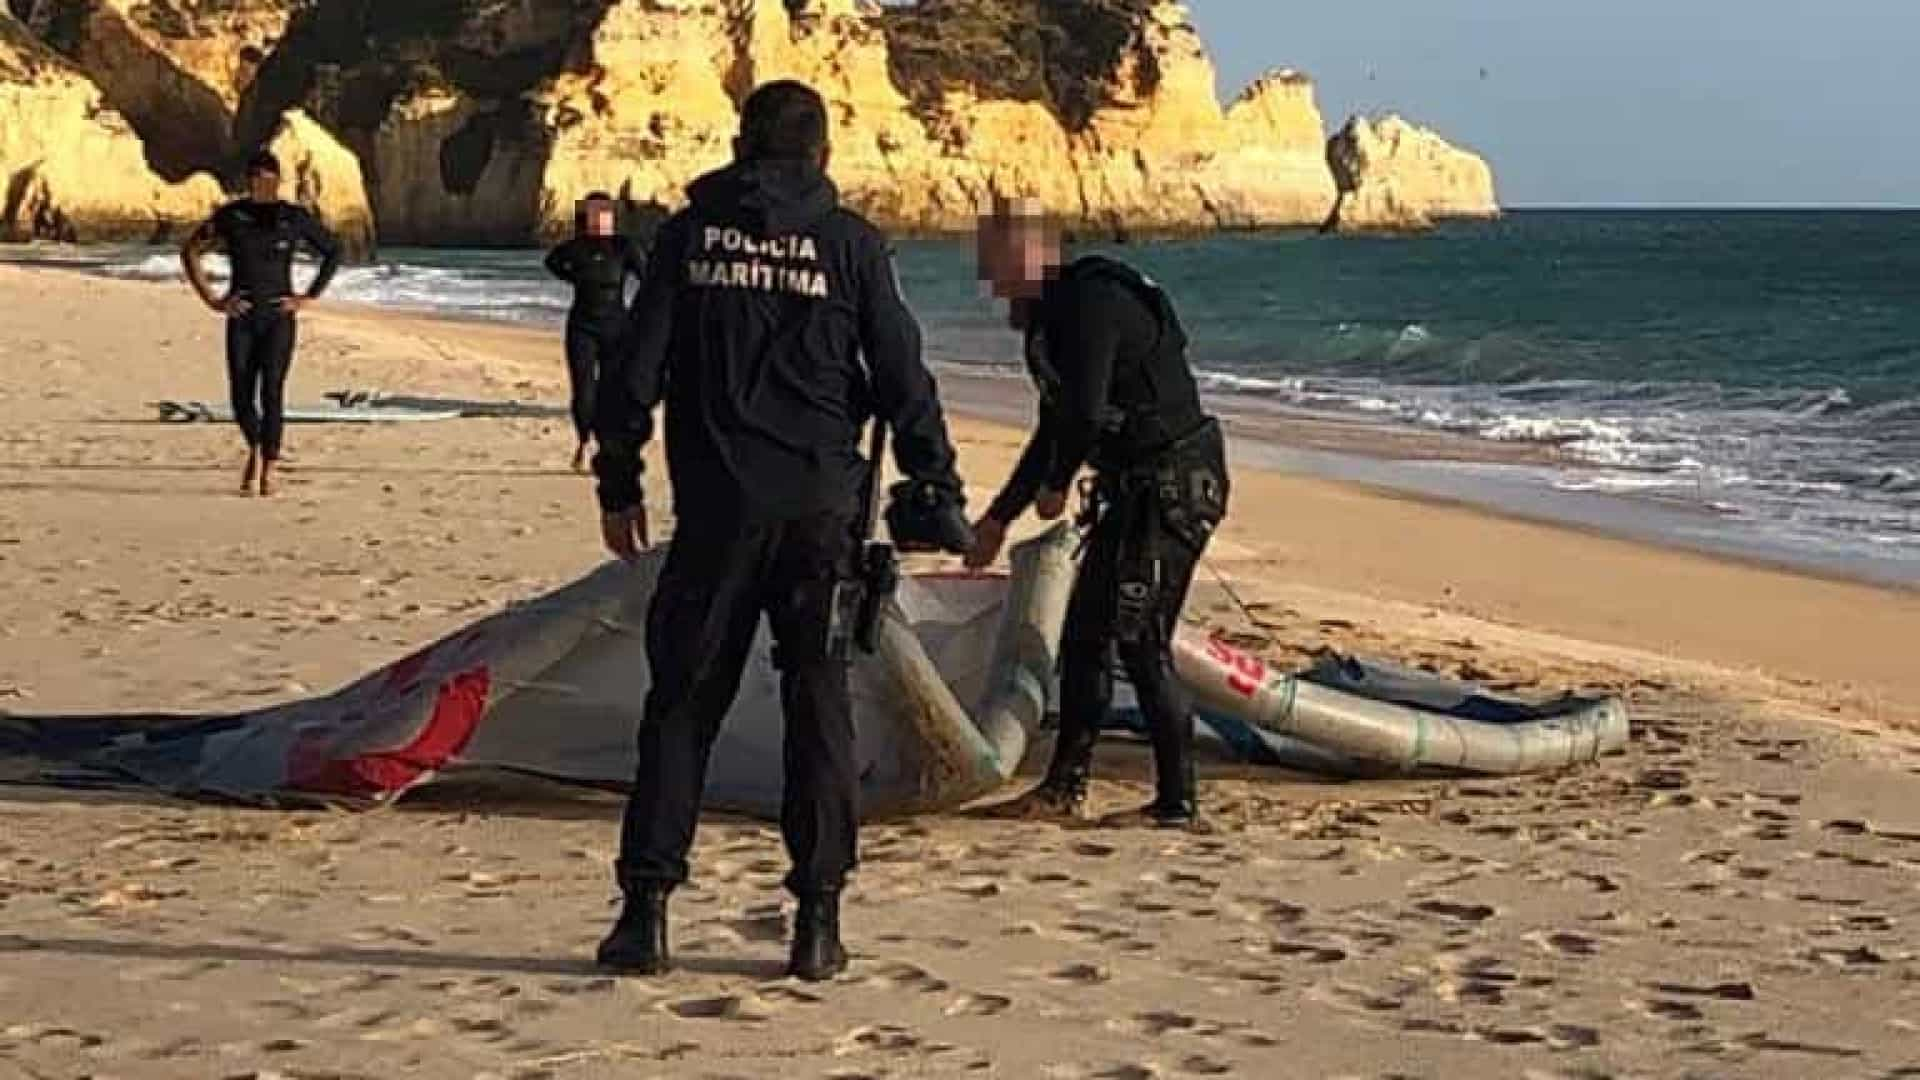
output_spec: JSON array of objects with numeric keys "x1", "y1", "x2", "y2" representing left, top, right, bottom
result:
[{"x1": 987, "y1": 256, "x2": 1208, "y2": 523}]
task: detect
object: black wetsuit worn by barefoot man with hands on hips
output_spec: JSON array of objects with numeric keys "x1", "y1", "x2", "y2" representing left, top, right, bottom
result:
[{"x1": 207, "y1": 200, "x2": 340, "y2": 461}]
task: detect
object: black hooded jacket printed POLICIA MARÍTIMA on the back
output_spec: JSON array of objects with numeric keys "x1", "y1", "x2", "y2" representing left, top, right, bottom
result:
[{"x1": 593, "y1": 161, "x2": 960, "y2": 521}]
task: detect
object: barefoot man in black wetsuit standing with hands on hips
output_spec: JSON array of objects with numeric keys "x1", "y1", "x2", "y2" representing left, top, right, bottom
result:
[{"x1": 180, "y1": 152, "x2": 340, "y2": 496}]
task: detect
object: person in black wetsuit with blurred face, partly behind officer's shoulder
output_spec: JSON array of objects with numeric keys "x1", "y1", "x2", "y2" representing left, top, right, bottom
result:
[{"x1": 547, "y1": 192, "x2": 647, "y2": 471}]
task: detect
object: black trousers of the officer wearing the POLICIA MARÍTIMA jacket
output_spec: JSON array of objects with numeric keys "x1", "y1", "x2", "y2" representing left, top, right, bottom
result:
[{"x1": 618, "y1": 511, "x2": 860, "y2": 896}]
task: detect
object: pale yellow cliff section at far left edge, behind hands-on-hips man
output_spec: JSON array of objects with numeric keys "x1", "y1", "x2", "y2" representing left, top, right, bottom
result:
[{"x1": 0, "y1": 10, "x2": 221, "y2": 240}]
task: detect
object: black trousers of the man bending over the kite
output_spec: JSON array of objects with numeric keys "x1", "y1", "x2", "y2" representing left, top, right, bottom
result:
[{"x1": 1048, "y1": 427, "x2": 1227, "y2": 805}]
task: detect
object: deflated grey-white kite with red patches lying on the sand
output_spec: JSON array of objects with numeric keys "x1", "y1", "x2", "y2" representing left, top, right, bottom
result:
[{"x1": 0, "y1": 525, "x2": 1626, "y2": 819}]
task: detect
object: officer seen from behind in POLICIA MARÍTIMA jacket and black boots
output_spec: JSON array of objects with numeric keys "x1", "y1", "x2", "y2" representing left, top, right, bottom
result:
[{"x1": 593, "y1": 83, "x2": 972, "y2": 980}]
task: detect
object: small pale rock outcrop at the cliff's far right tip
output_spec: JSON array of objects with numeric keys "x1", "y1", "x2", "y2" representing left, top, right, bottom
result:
[{"x1": 1327, "y1": 115, "x2": 1500, "y2": 231}]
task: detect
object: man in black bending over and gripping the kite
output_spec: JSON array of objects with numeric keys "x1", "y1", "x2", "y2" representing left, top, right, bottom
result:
[{"x1": 966, "y1": 202, "x2": 1227, "y2": 828}]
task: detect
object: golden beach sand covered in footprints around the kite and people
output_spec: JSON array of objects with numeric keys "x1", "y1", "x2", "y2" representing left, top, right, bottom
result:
[{"x1": 0, "y1": 267, "x2": 1920, "y2": 1078}]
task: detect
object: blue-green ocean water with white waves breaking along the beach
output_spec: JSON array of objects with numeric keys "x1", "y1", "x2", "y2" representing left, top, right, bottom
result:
[{"x1": 0, "y1": 211, "x2": 1920, "y2": 582}]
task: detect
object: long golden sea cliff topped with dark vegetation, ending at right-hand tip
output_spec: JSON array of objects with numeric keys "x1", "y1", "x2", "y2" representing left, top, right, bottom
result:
[{"x1": 12, "y1": 0, "x2": 1498, "y2": 244}]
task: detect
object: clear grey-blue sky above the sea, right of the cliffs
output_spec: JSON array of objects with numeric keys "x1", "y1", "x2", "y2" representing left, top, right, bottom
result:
[{"x1": 1190, "y1": 0, "x2": 1920, "y2": 206}]
